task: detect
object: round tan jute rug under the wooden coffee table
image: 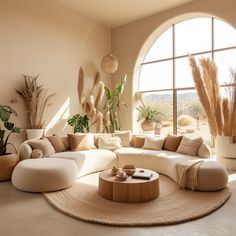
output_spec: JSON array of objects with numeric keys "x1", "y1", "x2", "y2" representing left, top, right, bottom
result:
[{"x1": 44, "y1": 173, "x2": 230, "y2": 226}]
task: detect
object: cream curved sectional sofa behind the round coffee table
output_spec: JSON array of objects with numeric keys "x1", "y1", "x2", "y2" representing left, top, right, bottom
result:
[{"x1": 19, "y1": 133, "x2": 228, "y2": 191}]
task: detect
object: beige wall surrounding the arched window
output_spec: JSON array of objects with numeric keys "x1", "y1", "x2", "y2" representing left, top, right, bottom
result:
[{"x1": 111, "y1": 0, "x2": 236, "y2": 132}]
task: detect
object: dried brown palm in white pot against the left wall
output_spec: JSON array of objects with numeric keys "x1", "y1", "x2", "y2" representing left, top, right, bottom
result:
[{"x1": 16, "y1": 75, "x2": 55, "y2": 139}]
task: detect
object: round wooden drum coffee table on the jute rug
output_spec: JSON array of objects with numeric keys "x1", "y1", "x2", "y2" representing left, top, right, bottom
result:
[{"x1": 99, "y1": 168, "x2": 159, "y2": 203}]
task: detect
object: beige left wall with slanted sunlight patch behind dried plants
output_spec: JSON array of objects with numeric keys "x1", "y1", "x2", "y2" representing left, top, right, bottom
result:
[{"x1": 0, "y1": 0, "x2": 111, "y2": 148}]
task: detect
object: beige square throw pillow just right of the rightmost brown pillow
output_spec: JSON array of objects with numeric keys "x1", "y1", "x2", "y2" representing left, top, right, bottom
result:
[{"x1": 176, "y1": 136, "x2": 203, "y2": 156}]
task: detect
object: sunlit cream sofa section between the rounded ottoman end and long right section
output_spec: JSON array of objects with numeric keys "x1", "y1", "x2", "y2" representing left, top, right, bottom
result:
[{"x1": 51, "y1": 149, "x2": 117, "y2": 177}]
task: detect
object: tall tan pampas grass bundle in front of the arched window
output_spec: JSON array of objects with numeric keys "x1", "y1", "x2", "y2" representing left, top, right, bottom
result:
[{"x1": 189, "y1": 56, "x2": 236, "y2": 137}]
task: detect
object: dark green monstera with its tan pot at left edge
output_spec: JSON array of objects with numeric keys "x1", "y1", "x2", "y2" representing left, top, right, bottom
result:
[{"x1": 0, "y1": 104, "x2": 20, "y2": 181}]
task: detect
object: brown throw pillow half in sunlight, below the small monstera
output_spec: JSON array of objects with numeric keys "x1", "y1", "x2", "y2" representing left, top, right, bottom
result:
[{"x1": 67, "y1": 134, "x2": 91, "y2": 151}]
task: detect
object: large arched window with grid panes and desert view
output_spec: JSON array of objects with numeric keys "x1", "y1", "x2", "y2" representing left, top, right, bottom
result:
[{"x1": 139, "y1": 17, "x2": 236, "y2": 142}]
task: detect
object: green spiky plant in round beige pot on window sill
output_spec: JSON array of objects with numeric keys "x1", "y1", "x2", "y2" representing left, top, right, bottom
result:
[{"x1": 136, "y1": 100, "x2": 164, "y2": 131}]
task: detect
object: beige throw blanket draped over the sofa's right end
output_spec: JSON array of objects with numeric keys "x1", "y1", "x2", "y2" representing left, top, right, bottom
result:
[{"x1": 176, "y1": 160, "x2": 203, "y2": 190}]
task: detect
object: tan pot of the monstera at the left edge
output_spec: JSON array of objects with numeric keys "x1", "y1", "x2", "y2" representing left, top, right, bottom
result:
[{"x1": 0, "y1": 153, "x2": 19, "y2": 181}]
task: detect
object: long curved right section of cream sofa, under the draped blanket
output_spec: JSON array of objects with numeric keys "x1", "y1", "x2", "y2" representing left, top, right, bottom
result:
[{"x1": 115, "y1": 148, "x2": 228, "y2": 191}]
